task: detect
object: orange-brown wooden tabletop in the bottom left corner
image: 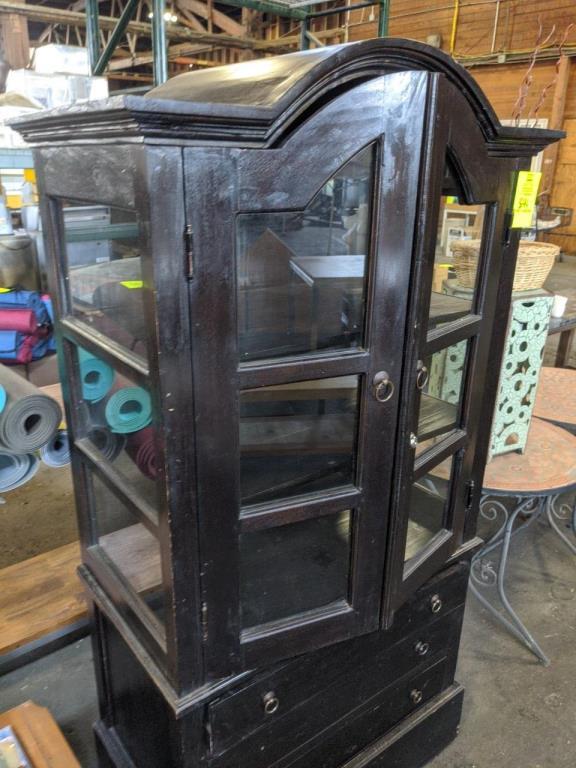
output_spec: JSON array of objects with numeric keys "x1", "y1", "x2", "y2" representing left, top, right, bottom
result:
[{"x1": 0, "y1": 701, "x2": 80, "y2": 768}]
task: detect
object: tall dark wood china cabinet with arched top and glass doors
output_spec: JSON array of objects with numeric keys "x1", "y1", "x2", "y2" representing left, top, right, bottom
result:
[{"x1": 13, "y1": 39, "x2": 559, "y2": 768}]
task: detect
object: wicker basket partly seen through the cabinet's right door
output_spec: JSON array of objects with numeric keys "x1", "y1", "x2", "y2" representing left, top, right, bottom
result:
[{"x1": 450, "y1": 240, "x2": 560, "y2": 291}]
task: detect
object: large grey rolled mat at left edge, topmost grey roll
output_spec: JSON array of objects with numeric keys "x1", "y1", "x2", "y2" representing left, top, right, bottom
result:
[{"x1": 0, "y1": 365, "x2": 62, "y2": 453}]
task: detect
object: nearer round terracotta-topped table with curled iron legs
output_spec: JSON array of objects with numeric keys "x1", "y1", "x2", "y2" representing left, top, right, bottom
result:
[{"x1": 470, "y1": 418, "x2": 576, "y2": 664}]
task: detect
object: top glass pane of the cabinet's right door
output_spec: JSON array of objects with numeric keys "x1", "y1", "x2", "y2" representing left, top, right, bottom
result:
[{"x1": 428, "y1": 161, "x2": 486, "y2": 330}]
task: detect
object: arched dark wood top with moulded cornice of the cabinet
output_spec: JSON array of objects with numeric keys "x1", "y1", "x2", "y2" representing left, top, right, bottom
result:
[{"x1": 13, "y1": 38, "x2": 563, "y2": 157}]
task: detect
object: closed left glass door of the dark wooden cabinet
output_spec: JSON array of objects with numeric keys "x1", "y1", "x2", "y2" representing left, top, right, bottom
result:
[{"x1": 187, "y1": 73, "x2": 427, "y2": 670}]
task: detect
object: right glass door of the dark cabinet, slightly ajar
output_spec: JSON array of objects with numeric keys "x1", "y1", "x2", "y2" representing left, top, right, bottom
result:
[{"x1": 384, "y1": 138, "x2": 502, "y2": 622}]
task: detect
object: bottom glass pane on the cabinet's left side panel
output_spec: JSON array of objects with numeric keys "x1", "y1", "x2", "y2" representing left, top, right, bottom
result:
[{"x1": 92, "y1": 476, "x2": 166, "y2": 622}]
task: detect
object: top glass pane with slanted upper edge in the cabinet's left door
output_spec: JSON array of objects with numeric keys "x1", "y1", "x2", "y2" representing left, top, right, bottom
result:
[{"x1": 237, "y1": 146, "x2": 375, "y2": 361}]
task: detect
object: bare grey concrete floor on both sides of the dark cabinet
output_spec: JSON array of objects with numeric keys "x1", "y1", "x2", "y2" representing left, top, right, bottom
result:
[{"x1": 0, "y1": 510, "x2": 576, "y2": 768}]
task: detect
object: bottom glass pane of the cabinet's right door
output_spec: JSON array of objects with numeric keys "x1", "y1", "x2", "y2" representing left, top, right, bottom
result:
[{"x1": 404, "y1": 456, "x2": 454, "y2": 561}]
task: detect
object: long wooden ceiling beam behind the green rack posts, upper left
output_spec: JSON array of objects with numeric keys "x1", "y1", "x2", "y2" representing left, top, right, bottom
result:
[{"x1": 0, "y1": 0, "x2": 256, "y2": 49}]
